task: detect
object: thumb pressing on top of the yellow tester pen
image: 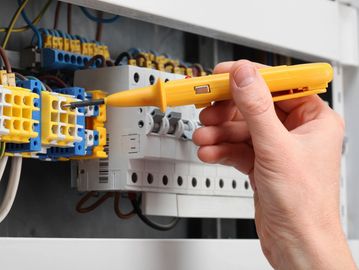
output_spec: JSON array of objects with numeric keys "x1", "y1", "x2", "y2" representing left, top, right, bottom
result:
[{"x1": 230, "y1": 60, "x2": 287, "y2": 146}]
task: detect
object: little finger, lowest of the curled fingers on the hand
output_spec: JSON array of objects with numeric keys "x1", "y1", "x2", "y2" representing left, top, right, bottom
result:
[{"x1": 198, "y1": 143, "x2": 254, "y2": 174}]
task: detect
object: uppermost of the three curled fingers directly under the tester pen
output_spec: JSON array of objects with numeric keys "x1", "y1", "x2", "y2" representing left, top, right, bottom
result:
[{"x1": 199, "y1": 100, "x2": 243, "y2": 126}]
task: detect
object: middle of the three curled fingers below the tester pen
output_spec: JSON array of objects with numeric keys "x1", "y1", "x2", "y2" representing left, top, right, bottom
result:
[{"x1": 192, "y1": 121, "x2": 250, "y2": 146}]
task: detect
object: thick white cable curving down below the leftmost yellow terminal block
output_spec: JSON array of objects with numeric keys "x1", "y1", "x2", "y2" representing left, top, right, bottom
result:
[{"x1": 0, "y1": 157, "x2": 22, "y2": 223}]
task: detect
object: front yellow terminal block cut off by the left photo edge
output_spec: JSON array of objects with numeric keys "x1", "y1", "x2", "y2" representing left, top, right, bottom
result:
[{"x1": 0, "y1": 86, "x2": 40, "y2": 143}]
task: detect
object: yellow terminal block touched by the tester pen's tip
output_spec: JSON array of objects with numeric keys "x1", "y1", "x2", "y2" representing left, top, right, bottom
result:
[{"x1": 41, "y1": 91, "x2": 84, "y2": 147}]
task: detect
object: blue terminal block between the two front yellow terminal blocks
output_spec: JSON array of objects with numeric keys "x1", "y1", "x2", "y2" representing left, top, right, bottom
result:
[{"x1": 6, "y1": 80, "x2": 41, "y2": 153}]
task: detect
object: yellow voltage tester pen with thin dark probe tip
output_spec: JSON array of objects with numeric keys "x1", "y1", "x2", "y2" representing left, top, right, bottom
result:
[{"x1": 64, "y1": 63, "x2": 333, "y2": 112}]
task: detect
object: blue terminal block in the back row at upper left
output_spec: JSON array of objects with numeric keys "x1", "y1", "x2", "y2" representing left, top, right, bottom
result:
[{"x1": 41, "y1": 48, "x2": 99, "y2": 70}]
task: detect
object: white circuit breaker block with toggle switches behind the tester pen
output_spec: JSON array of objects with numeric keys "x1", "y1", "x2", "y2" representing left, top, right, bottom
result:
[{"x1": 73, "y1": 65, "x2": 253, "y2": 217}]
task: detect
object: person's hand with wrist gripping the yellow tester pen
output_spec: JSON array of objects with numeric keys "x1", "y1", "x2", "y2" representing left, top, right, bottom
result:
[{"x1": 193, "y1": 60, "x2": 356, "y2": 270}]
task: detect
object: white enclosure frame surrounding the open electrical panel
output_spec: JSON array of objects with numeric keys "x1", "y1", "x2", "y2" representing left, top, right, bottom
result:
[{"x1": 0, "y1": 0, "x2": 359, "y2": 270}]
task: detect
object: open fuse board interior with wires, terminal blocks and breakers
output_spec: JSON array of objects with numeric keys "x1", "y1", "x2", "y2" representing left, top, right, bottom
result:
[{"x1": 0, "y1": 0, "x2": 345, "y2": 243}]
